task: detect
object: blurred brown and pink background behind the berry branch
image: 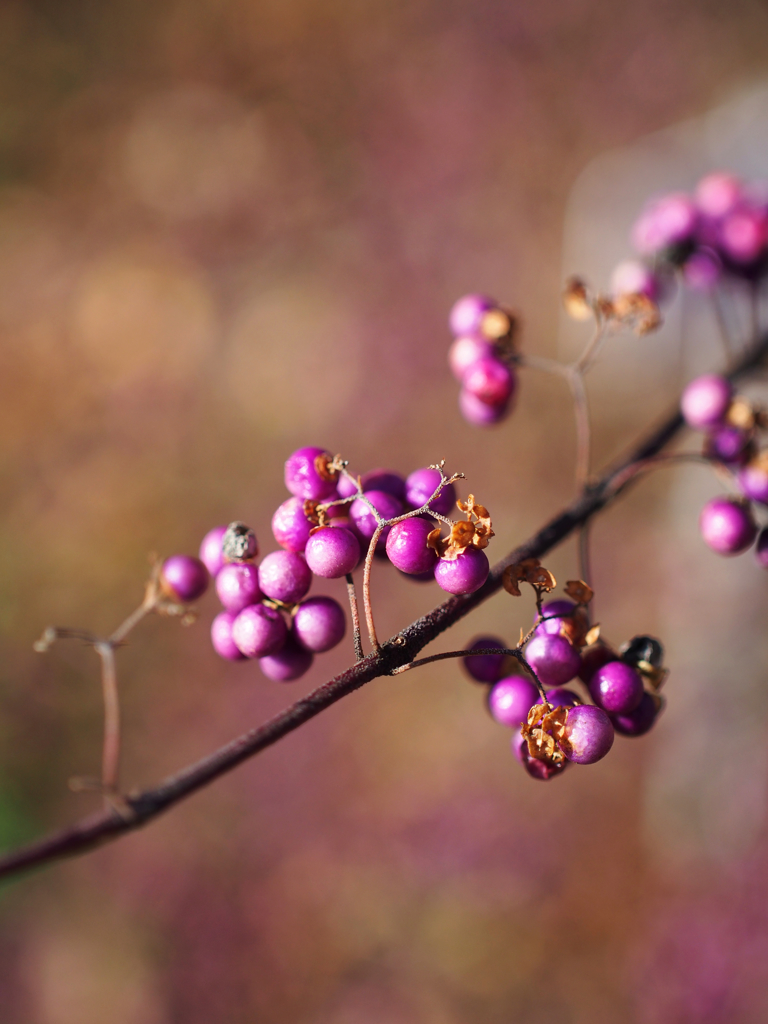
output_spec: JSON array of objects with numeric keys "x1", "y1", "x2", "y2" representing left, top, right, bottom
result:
[{"x1": 0, "y1": 0, "x2": 768, "y2": 1024}]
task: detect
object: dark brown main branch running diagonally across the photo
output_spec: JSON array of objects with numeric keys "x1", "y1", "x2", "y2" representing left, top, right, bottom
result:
[{"x1": 0, "y1": 336, "x2": 768, "y2": 879}]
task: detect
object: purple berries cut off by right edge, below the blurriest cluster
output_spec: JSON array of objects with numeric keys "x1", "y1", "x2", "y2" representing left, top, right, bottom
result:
[{"x1": 681, "y1": 374, "x2": 768, "y2": 568}]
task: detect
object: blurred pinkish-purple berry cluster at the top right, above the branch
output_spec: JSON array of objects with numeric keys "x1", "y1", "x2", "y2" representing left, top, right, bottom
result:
[{"x1": 611, "y1": 171, "x2": 768, "y2": 302}]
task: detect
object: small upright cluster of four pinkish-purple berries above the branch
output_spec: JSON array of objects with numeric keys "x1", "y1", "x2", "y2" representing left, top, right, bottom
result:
[{"x1": 449, "y1": 295, "x2": 517, "y2": 427}]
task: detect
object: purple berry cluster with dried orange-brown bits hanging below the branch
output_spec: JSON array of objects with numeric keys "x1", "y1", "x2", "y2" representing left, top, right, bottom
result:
[{"x1": 464, "y1": 600, "x2": 666, "y2": 780}]
